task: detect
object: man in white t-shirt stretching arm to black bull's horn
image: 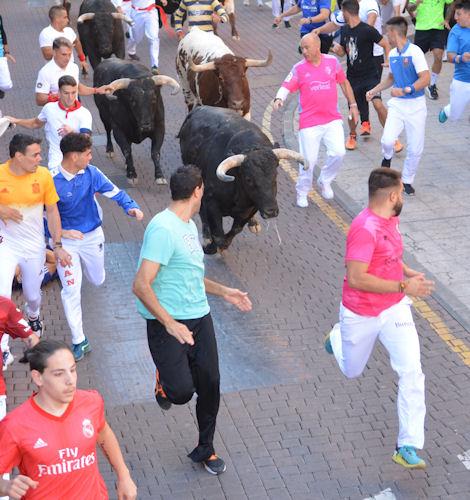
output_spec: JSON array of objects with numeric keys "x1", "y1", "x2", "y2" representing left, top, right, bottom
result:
[{"x1": 36, "y1": 37, "x2": 114, "y2": 106}]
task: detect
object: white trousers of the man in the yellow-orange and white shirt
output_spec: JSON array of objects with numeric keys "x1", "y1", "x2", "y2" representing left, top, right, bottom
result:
[{"x1": 0, "y1": 245, "x2": 46, "y2": 351}]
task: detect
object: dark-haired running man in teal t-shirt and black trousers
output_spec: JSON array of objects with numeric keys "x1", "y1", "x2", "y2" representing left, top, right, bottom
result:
[{"x1": 133, "y1": 166, "x2": 251, "y2": 474}]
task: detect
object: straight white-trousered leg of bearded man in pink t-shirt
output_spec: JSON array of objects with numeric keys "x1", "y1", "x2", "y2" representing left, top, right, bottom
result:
[{"x1": 379, "y1": 298, "x2": 426, "y2": 449}]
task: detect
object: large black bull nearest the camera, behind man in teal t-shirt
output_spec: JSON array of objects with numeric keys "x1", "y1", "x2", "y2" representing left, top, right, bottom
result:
[{"x1": 178, "y1": 106, "x2": 304, "y2": 254}]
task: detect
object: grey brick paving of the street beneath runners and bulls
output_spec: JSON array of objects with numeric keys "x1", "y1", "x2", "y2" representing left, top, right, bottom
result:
[{"x1": 0, "y1": 0, "x2": 470, "y2": 500}]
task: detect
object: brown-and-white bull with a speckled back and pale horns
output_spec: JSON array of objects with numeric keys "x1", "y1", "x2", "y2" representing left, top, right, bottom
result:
[{"x1": 176, "y1": 29, "x2": 272, "y2": 119}]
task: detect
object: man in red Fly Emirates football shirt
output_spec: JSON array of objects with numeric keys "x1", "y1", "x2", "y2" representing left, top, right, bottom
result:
[{"x1": 0, "y1": 340, "x2": 137, "y2": 500}]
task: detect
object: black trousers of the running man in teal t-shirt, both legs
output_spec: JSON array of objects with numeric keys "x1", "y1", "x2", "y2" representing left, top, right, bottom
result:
[{"x1": 147, "y1": 314, "x2": 220, "y2": 462}]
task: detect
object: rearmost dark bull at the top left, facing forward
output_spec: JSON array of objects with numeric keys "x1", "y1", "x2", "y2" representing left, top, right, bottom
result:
[{"x1": 77, "y1": 0, "x2": 133, "y2": 69}]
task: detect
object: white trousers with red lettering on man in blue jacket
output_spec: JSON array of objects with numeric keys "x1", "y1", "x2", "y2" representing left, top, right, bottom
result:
[{"x1": 57, "y1": 227, "x2": 105, "y2": 344}]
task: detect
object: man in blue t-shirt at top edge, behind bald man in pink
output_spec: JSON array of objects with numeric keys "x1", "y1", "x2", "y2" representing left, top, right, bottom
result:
[{"x1": 274, "y1": 0, "x2": 333, "y2": 54}]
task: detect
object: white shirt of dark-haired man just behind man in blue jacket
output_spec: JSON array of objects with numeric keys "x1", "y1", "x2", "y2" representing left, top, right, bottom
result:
[{"x1": 38, "y1": 102, "x2": 92, "y2": 174}]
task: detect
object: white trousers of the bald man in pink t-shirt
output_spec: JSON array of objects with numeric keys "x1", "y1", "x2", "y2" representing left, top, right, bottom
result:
[{"x1": 296, "y1": 120, "x2": 346, "y2": 196}]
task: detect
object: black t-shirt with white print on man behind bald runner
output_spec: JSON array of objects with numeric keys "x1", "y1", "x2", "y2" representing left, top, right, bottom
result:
[{"x1": 340, "y1": 22, "x2": 382, "y2": 80}]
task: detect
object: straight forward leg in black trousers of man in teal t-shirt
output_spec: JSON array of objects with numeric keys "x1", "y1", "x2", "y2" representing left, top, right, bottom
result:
[{"x1": 188, "y1": 314, "x2": 220, "y2": 462}]
